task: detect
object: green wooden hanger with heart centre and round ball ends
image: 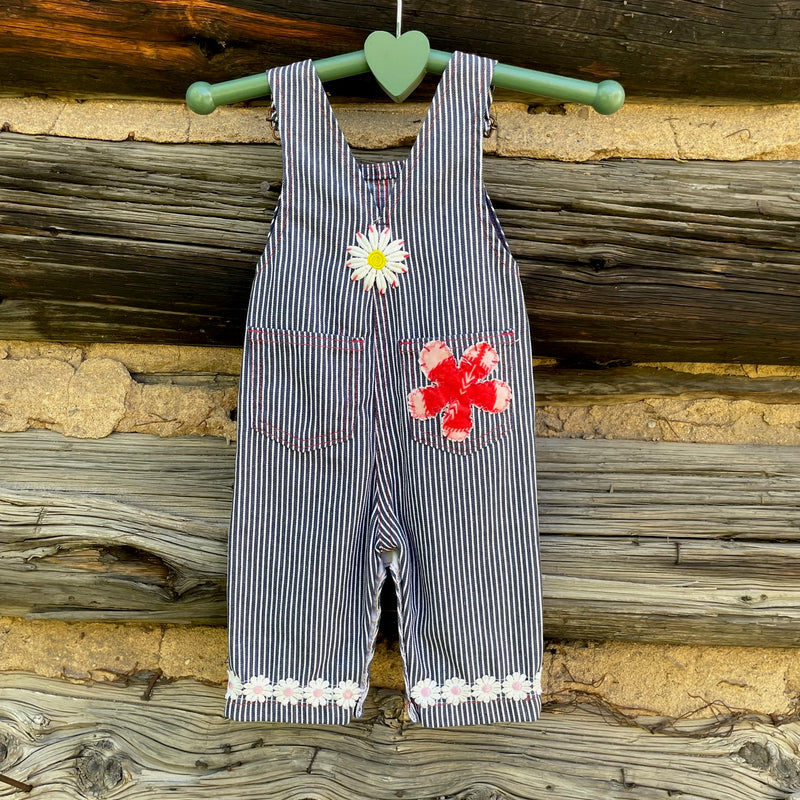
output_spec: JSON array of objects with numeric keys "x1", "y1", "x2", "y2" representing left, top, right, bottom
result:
[{"x1": 186, "y1": 0, "x2": 625, "y2": 114}]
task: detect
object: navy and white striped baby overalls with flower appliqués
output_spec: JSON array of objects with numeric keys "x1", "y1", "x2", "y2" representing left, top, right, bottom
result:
[{"x1": 225, "y1": 52, "x2": 542, "y2": 727}]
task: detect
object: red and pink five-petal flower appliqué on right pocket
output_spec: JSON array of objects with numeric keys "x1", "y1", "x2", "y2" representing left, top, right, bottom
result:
[{"x1": 408, "y1": 341, "x2": 511, "y2": 442}]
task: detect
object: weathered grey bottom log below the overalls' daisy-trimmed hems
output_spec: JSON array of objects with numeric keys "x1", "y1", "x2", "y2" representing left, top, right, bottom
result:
[{"x1": 0, "y1": 673, "x2": 800, "y2": 800}]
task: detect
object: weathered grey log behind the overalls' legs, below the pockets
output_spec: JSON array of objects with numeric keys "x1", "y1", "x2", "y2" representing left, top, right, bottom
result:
[{"x1": 0, "y1": 431, "x2": 800, "y2": 647}]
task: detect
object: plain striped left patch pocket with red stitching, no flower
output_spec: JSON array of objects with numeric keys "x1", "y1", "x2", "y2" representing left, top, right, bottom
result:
[{"x1": 248, "y1": 328, "x2": 364, "y2": 452}]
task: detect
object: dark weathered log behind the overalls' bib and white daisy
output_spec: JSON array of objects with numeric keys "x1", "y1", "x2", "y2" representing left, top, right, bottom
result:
[{"x1": 0, "y1": 134, "x2": 800, "y2": 364}]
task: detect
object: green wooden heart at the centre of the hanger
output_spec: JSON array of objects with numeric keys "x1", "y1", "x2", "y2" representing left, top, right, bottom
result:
[{"x1": 364, "y1": 31, "x2": 431, "y2": 103}]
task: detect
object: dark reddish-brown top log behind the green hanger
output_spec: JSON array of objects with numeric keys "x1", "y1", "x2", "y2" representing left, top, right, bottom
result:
[{"x1": 0, "y1": 0, "x2": 800, "y2": 102}]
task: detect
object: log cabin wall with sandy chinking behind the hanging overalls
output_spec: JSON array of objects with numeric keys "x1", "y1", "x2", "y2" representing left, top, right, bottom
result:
[{"x1": 0, "y1": 0, "x2": 800, "y2": 800}]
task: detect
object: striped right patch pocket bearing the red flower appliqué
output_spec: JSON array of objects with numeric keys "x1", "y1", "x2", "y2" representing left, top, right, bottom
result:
[{"x1": 398, "y1": 331, "x2": 517, "y2": 455}]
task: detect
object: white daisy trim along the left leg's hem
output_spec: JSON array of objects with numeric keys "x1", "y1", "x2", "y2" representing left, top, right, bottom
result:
[{"x1": 225, "y1": 670, "x2": 363, "y2": 708}]
